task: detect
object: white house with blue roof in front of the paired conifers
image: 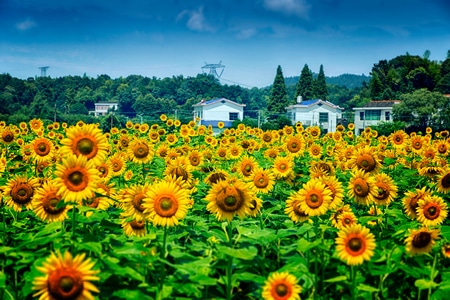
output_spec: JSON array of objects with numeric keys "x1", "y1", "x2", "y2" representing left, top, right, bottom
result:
[{"x1": 286, "y1": 96, "x2": 343, "y2": 133}]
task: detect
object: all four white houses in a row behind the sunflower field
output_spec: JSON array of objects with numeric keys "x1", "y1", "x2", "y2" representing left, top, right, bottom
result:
[{"x1": 94, "y1": 96, "x2": 400, "y2": 135}]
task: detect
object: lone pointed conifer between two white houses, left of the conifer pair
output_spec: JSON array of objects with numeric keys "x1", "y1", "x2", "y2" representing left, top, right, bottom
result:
[{"x1": 267, "y1": 66, "x2": 290, "y2": 119}]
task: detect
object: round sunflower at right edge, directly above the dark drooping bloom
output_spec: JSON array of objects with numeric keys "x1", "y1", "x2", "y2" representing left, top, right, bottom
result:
[{"x1": 416, "y1": 195, "x2": 448, "y2": 226}]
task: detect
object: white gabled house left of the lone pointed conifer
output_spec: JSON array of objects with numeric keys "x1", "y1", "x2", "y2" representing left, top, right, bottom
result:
[{"x1": 192, "y1": 98, "x2": 245, "y2": 127}]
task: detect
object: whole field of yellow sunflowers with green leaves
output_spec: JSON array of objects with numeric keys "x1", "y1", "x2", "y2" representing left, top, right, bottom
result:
[{"x1": 0, "y1": 115, "x2": 450, "y2": 300}]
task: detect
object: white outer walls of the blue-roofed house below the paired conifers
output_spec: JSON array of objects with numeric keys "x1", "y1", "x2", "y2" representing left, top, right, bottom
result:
[{"x1": 287, "y1": 105, "x2": 342, "y2": 132}]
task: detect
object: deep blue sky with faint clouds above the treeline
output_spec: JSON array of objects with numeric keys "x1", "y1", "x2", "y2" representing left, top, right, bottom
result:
[{"x1": 0, "y1": 0, "x2": 450, "y2": 87}]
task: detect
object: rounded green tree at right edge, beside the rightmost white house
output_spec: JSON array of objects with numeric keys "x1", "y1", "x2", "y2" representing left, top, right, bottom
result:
[{"x1": 393, "y1": 89, "x2": 450, "y2": 130}]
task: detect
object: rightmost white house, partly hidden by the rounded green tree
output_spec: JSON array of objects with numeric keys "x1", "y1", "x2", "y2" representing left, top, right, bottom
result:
[{"x1": 353, "y1": 100, "x2": 400, "y2": 135}]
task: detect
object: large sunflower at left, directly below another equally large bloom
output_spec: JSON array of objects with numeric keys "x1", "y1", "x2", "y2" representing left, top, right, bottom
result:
[{"x1": 54, "y1": 154, "x2": 100, "y2": 204}]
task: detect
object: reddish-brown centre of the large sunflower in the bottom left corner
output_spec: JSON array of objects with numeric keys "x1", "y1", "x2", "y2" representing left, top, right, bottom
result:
[{"x1": 48, "y1": 268, "x2": 84, "y2": 299}]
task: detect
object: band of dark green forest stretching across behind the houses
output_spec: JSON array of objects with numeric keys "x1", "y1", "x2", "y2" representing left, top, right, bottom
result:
[{"x1": 0, "y1": 51, "x2": 450, "y2": 131}]
